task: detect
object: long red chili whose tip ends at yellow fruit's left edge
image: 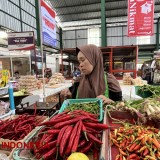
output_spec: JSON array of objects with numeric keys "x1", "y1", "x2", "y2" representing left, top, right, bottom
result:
[{"x1": 65, "y1": 121, "x2": 80, "y2": 155}]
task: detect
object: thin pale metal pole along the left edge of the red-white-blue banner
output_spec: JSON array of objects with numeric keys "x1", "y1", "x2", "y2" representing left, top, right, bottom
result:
[{"x1": 39, "y1": 1, "x2": 46, "y2": 102}]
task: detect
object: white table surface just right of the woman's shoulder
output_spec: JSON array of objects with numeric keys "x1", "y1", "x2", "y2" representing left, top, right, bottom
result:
[{"x1": 119, "y1": 80, "x2": 142, "y2": 101}]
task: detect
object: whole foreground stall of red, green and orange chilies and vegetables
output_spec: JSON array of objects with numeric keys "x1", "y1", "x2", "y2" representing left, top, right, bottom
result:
[{"x1": 0, "y1": 86, "x2": 160, "y2": 160}]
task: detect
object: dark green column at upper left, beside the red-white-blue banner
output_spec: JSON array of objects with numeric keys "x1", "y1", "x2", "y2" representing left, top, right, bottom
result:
[{"x1": 35, "y1": 0, "x2": 41, "y2": 46}]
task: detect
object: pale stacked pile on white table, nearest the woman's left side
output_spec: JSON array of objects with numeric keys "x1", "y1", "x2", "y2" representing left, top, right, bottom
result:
[{"x1": 49, "y1": 73, "x2": 65, "y2": 85}]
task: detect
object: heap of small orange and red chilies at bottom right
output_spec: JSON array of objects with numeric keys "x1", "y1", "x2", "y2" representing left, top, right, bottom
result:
[{"x1": 110, "y1": 125, "x2": 160, "y2": 160}]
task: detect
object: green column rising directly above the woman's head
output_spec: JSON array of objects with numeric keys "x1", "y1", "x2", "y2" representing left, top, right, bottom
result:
[{"x1": 101, "y1": 0, "x2": 107, "y2": 47}]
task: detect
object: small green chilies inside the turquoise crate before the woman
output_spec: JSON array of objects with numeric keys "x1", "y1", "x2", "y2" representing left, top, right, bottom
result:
[{"x1": 66, "y1": 102, "x2": 99, "y2": 114}]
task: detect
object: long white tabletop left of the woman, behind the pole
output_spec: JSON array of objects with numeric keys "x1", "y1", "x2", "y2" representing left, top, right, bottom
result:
[{"x1": 30, "y1": 80, "x2": 72, "y2": 102}]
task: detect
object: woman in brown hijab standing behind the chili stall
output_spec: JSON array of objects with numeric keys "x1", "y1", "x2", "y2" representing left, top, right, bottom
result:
[{"x1": 61, "y1": 45, "x2": 122, "y2": 104}]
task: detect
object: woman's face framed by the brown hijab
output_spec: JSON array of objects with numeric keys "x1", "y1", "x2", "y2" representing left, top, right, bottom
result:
[{"x1": 78, "y1": 51, "x2": 93, "y2": 75}]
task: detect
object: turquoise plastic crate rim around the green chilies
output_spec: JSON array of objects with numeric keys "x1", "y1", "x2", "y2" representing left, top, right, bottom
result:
[{"x1": 59, "y1": 98, "x2": 103, "y2": 122}]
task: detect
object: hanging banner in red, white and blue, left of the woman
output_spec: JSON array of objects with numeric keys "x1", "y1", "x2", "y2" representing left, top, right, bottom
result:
[{"x1": 41, "y1": 0, "x2": 56, "y2": 47}]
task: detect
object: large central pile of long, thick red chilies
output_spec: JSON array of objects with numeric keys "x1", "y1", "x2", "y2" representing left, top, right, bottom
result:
[{"x1": 34, "y1": 110, "x2": 108, "y2": 160}]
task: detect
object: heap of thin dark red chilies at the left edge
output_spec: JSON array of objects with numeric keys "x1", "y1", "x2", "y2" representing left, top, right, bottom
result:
[{"x1": 0, "y1": 114, "x2": 44, "y2": 141}]
